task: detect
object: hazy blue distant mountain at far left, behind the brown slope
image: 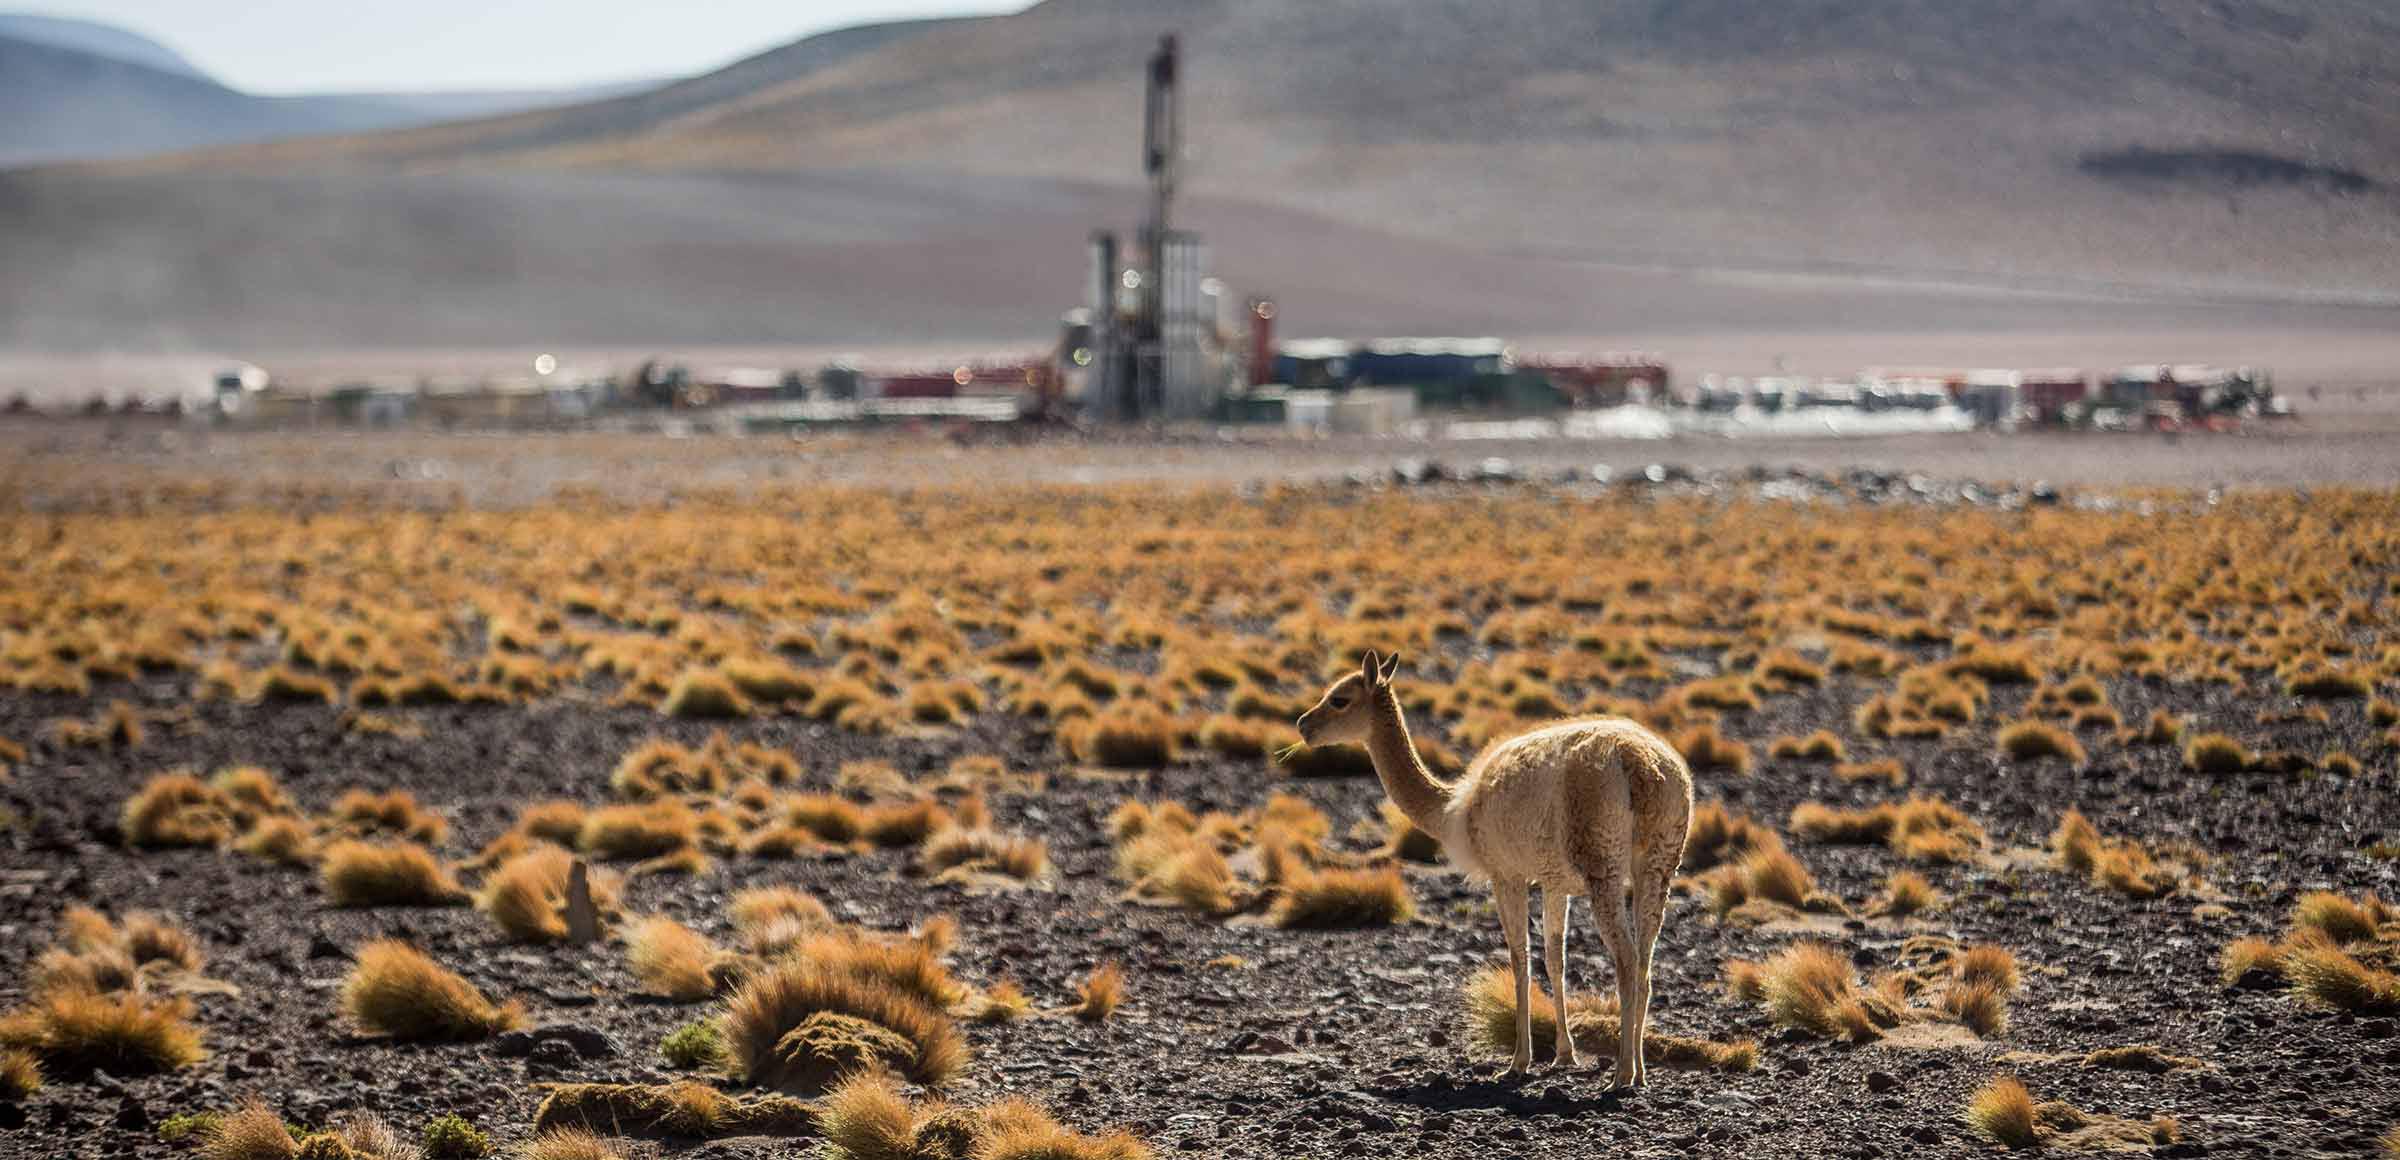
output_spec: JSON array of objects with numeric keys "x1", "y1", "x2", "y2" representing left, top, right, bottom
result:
[{"x1": 0, "y1": 14, "x2": 650, "y2": 166}]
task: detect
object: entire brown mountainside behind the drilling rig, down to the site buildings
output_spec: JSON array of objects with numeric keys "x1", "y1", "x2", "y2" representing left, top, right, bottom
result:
[{"x1": 0, "y1": 0, "x2": 2400, "y2": 353}]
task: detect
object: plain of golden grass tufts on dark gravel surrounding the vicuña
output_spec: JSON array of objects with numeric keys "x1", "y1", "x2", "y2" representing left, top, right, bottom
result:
[{"x1": 18, "y1": 463, "x2": 2400, "y2": 1160}]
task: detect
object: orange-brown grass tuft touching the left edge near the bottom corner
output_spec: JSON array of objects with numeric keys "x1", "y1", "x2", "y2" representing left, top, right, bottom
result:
[{"x1": 0, "y1": 987, "x2": 206, "y2": 1076}]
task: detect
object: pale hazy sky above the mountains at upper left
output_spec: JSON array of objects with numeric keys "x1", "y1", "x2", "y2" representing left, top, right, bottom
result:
[{"x1": 30, "y1": 0, "x2": 1030, "y2": 94}]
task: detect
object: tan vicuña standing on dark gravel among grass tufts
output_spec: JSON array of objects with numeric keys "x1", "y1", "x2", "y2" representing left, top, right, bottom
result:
[{"x1": 1298, "y1": 653, "x2": 1692, "y2": 1086}]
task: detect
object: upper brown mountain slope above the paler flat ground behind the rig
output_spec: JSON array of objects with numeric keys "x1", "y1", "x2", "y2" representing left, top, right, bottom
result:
[{"x1": 121, "y1": 0, "x2": 2400, "y2": 300}]
